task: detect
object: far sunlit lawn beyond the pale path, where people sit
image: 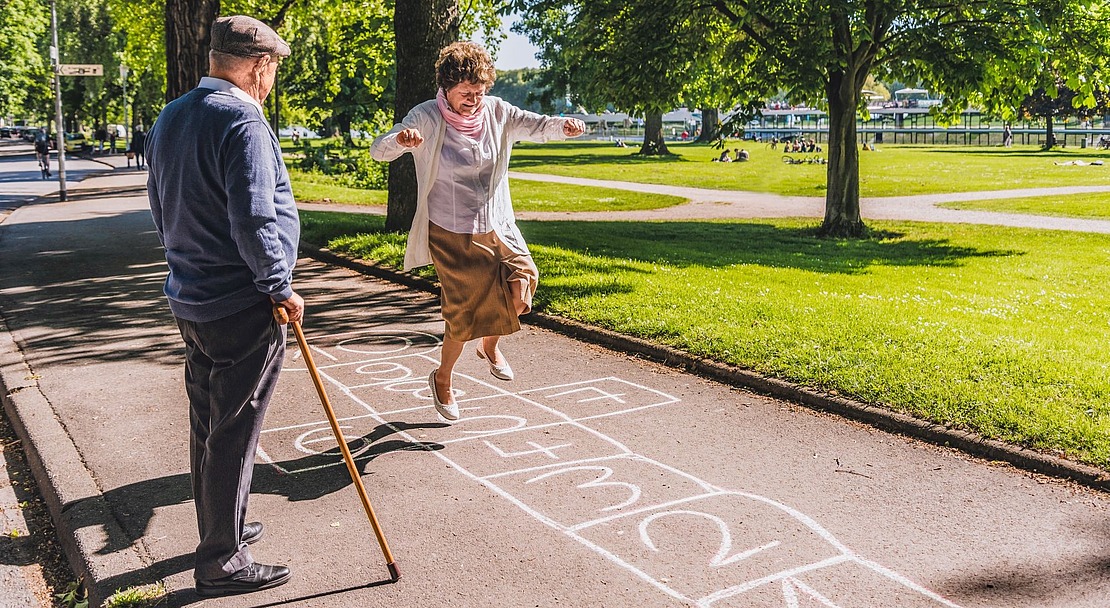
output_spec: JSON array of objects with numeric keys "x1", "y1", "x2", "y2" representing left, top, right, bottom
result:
[{"x1": 511, "y1": 141, "x2": 1110, "y2": 196}]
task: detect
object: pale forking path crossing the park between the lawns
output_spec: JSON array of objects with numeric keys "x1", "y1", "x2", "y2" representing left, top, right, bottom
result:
[{"x1": 300, "y1": 171, "x2": 1110, "y2": 234}]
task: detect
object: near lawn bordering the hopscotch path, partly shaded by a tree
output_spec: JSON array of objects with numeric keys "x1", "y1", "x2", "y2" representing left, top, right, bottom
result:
[{"x1": 303, "y1": 213, "x2": 1110, "y2": 468}]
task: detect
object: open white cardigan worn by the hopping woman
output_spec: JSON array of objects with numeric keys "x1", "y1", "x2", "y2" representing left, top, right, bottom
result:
[{"x1": 370, "y1": 97, "x2": 567, "y2": 271}]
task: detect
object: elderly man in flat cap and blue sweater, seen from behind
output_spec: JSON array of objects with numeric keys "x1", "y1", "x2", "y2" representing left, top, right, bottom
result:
[{"x1": 147, "y1": 16, "x2": 304, "y2": 596}]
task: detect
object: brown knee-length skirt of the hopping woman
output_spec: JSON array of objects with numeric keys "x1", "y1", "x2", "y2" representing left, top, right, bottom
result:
[{"x1": 427, "y1": 222, "x2": 539, "y2": 342}]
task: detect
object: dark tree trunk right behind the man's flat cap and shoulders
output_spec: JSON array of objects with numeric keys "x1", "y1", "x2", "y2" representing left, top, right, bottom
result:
[{"x1": 165, "y1": 0, "x2": 220, "y2": 102}]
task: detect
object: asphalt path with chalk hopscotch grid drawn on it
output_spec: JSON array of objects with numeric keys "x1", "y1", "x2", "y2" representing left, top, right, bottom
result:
[{"x1": 0, "y1": 146, "x2": 1110, "y2": 608}]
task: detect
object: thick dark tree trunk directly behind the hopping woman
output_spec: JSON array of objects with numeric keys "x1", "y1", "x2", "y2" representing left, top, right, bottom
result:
[{"x1": 385, "y1": 0, "x2": 458, "y2": 232}]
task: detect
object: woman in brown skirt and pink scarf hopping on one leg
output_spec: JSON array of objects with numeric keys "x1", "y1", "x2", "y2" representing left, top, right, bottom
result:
[{"x1": 371, "y1": 42, "x2": 586, "y2": 422}]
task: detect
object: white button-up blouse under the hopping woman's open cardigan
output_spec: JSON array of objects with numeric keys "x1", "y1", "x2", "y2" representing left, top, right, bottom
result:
[{"x1": 427, "y1": 125, "x2": 496, "y2": 234}]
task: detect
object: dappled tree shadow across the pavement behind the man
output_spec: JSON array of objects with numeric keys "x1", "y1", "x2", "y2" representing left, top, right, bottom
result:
[{"x1": 0, "y1": 211, "x2": 438, "y2": 367}]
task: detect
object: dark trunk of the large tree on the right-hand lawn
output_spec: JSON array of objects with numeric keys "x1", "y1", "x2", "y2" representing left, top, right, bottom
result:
[{"x1": 818, "y1": 71, "x2": 867, "y2": 237}]
